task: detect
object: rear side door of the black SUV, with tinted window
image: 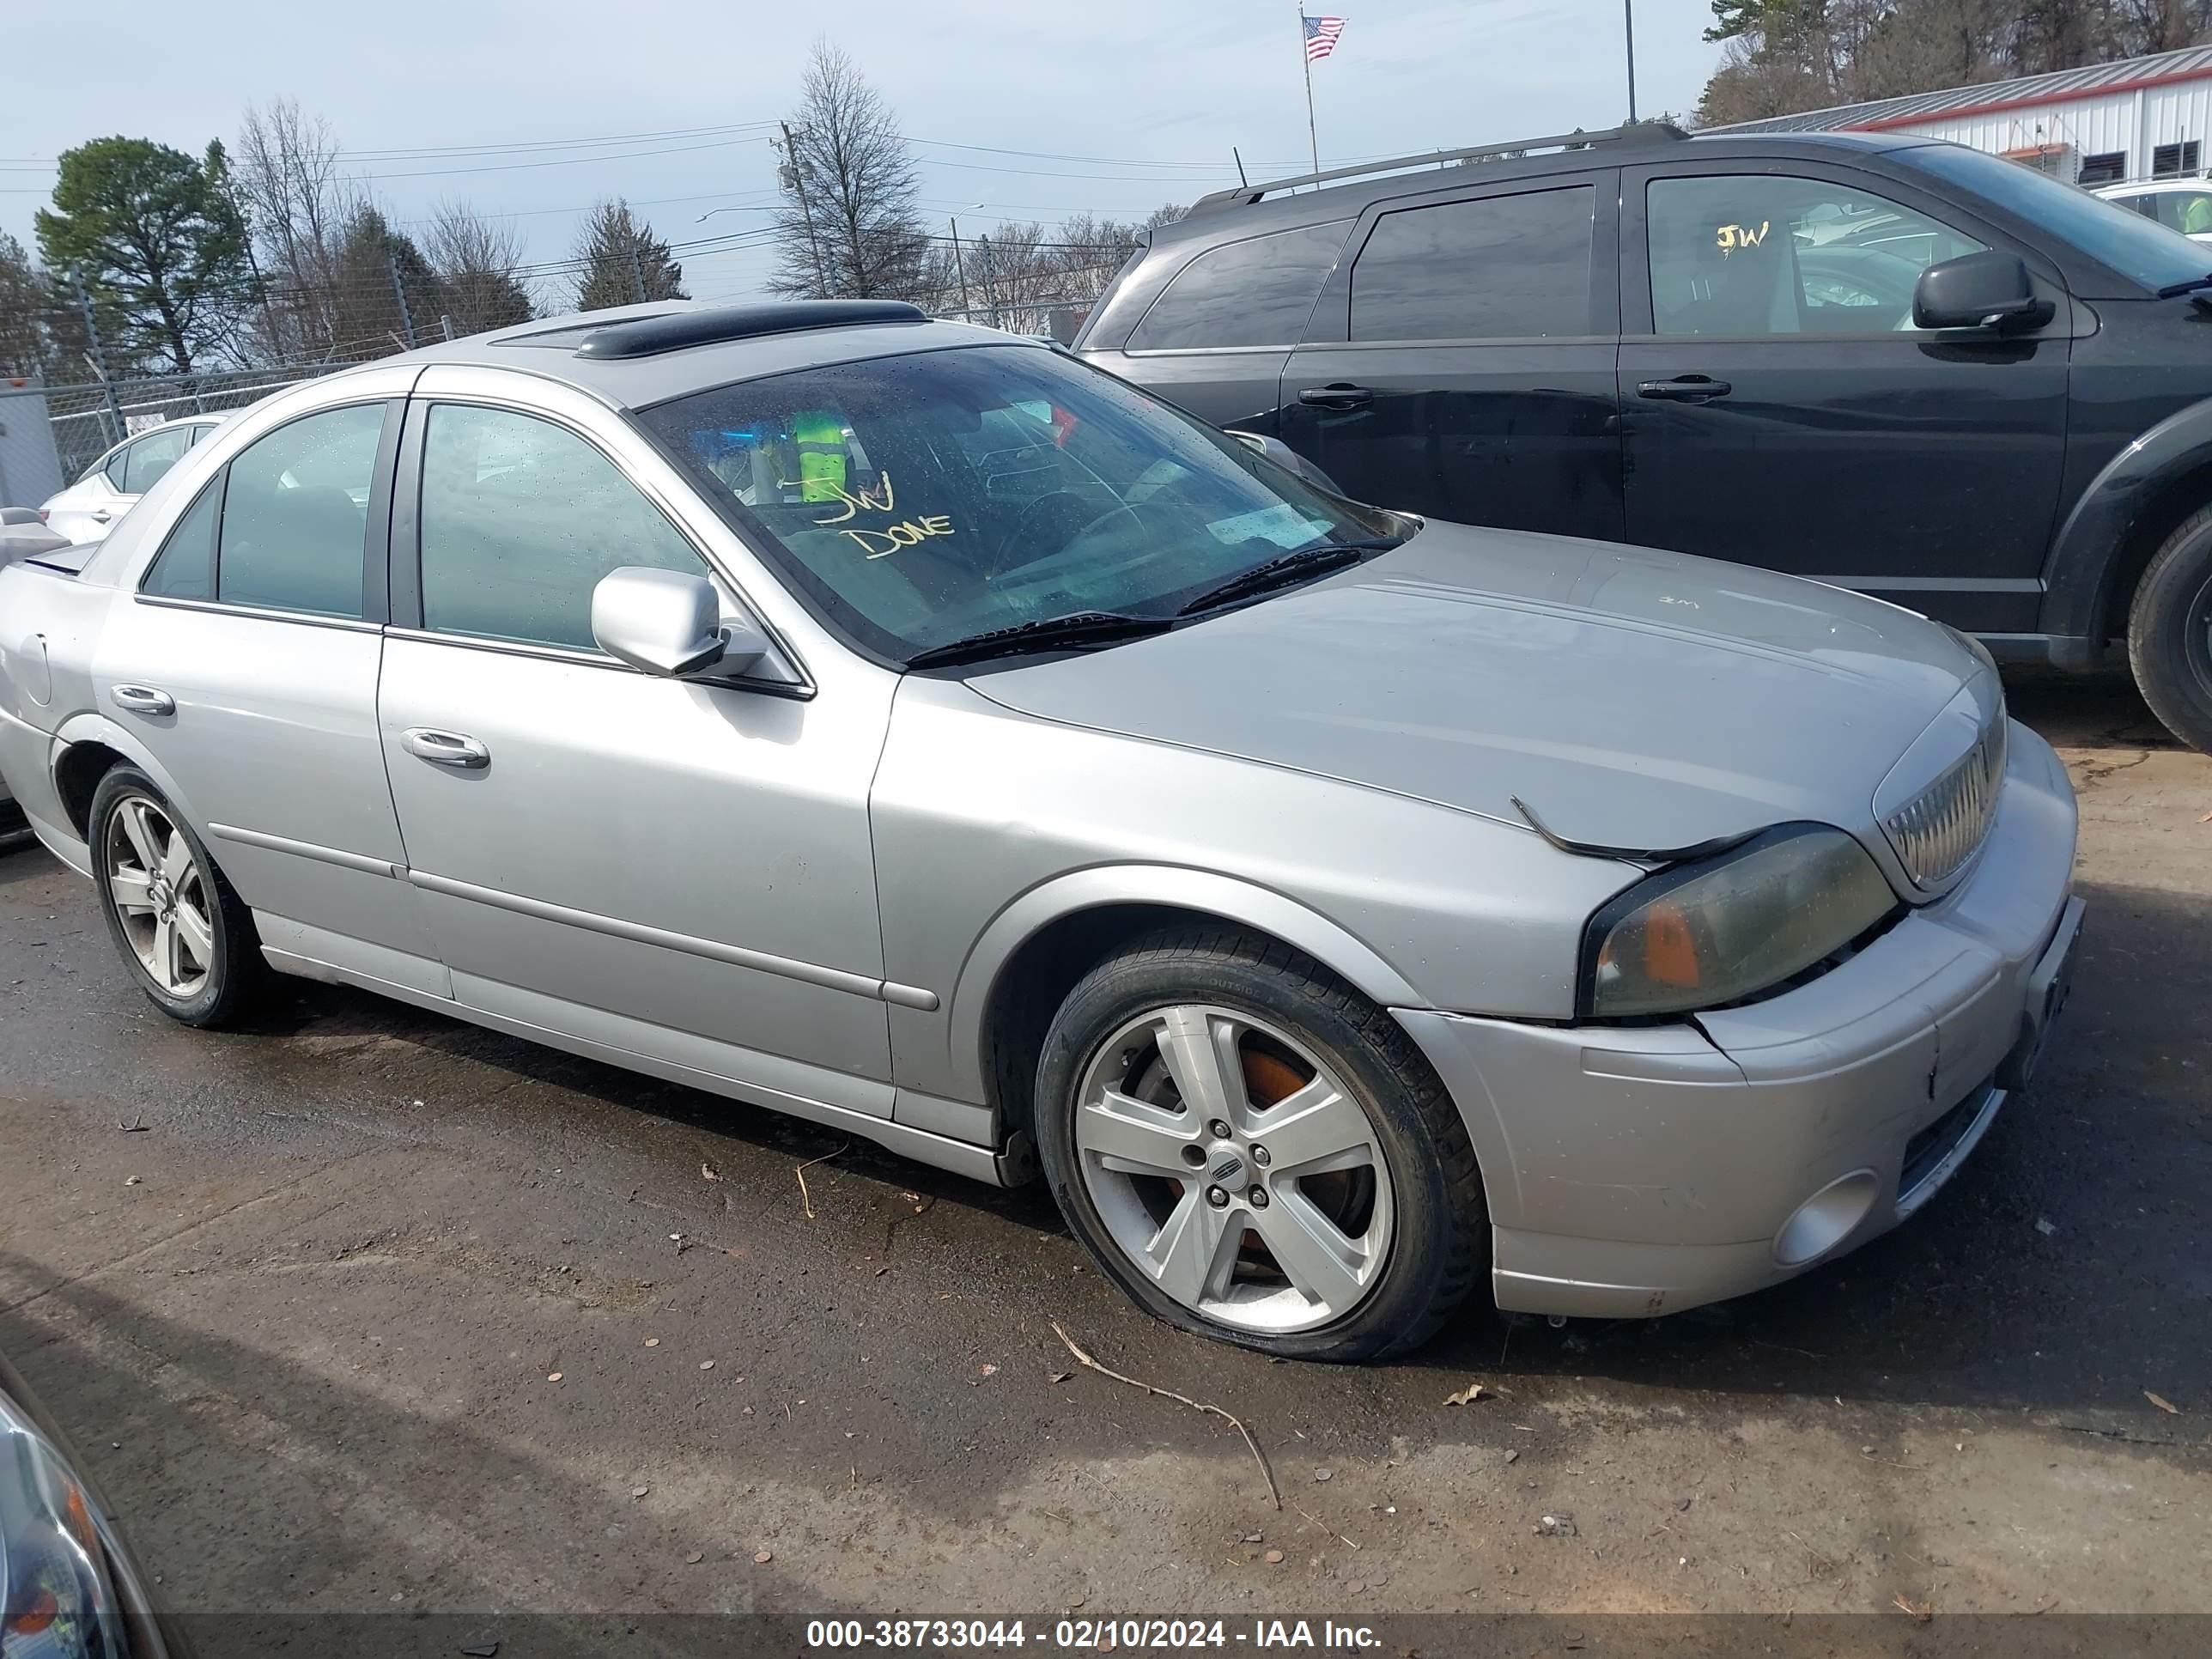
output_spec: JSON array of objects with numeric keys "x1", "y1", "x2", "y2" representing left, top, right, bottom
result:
[{"x1": 1281, "y1": 168, "x2": 1621, "y2": 540}]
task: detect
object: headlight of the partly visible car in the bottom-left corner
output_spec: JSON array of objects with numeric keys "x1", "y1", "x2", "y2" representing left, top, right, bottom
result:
[{"x1": 0, "y1": 1394, "x2": 131, "y2": 1659}]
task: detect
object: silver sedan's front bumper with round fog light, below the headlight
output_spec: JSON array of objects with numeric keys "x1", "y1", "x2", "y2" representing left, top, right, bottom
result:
[{"x1": 1394, "y1": 726, "x2": 2081, "y2": 1318}]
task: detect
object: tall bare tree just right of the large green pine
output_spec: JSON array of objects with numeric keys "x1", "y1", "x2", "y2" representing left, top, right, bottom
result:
[{"x1": 230, "y1": 97, "x2": 368, "y2": 361}]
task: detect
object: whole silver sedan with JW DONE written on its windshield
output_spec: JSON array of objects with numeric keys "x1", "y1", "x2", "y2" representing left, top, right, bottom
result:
[{"x1": 0, "y1": 303, "x2": 2079, "y2": 1358}]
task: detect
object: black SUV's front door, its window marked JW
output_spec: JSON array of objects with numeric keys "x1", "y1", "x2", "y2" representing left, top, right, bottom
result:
[{"x1": 1620, "y1": 161, "x2": 2070, "y2": 633}]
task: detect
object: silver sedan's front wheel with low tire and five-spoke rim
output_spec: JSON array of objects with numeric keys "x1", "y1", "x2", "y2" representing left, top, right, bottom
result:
[{"x1": 1036, "y1": 929, "x2": 1489, "y2": 1360}]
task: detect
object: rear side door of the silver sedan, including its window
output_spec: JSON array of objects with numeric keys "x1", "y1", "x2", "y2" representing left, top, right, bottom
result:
[{"x1": 95, "y1": 368, "x2": 445, "y2": 994}]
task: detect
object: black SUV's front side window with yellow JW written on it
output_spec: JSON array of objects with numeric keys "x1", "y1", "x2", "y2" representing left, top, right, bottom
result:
[{"x1": 1646, "y1": 173, "x2": 1990, "y2": 338}]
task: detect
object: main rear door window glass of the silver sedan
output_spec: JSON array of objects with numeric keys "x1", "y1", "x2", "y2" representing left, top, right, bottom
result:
[{"x1": 215, "y1": 403, "x2": 385, "y2": 617}]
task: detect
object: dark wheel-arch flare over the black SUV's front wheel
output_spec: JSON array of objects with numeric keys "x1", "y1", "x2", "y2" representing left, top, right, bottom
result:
[{"x1": 2042, "y1": 398, "x2": 2212, "y2": 668}]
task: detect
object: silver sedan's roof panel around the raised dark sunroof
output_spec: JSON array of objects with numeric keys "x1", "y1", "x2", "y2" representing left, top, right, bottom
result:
[{"x1": 330, "y1": 301, "x2": 1026, "y2": 410}]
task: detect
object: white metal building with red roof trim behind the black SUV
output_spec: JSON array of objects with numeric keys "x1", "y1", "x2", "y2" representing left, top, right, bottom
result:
[{"x1": 1710, "y1": 46, "x2": 2212, "y2": 184}]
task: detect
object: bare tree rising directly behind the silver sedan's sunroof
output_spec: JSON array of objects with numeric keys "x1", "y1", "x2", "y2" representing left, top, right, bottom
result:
[{"x1": 768, "y1": 40, "x2": 929, "y2": 299}]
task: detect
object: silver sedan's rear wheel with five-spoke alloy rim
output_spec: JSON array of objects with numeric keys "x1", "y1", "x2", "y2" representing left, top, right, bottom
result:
[{"x1": 91, "y1": 765, "x2": 268, "y2": 1026}]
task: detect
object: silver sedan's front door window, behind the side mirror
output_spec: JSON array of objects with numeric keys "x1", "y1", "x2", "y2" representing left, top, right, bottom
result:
[{"x1": 420, "y1": 403, "x2": 708, "y2": 650}]
